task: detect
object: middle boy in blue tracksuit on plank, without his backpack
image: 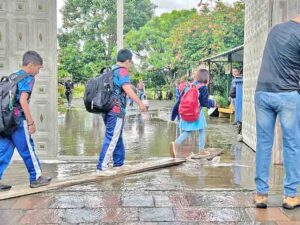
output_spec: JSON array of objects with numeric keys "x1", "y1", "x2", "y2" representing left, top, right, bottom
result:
[{"x1": 97, "y1": 49, "x2": 146, "y2": 171}]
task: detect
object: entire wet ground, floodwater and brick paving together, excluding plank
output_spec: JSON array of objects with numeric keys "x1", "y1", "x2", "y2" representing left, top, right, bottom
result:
[{"x1": 0, "y1": 100, "x2": 300, "y2": 225}]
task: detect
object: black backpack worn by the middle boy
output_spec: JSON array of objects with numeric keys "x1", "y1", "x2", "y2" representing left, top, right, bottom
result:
[{"x1": 83, "y1": 68, "x2": 119, "y2": 113}]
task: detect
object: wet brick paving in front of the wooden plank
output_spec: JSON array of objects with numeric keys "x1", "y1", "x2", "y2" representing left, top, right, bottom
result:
[{"x1": 0, "y1": 167, "x2": 300, "y2": 225}]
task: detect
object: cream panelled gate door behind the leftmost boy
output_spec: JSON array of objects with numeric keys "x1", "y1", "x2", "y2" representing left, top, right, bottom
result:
[{"x1": 0, "y1": 0, "x2": 58, "y2": 159}]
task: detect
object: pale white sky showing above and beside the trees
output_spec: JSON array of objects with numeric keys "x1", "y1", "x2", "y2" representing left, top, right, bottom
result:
[{"x1": 57, "y1": 0, "x2": 236, "y2": 28}]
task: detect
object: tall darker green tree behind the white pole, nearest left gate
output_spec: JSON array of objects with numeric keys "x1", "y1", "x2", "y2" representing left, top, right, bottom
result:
[{"x1": 58, "y1": 0, "x2": 155, "y2": 82}]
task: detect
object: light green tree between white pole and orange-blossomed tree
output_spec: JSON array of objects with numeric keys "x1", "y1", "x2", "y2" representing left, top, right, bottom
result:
[{"x1": 125, "y1": 10, "x2": 196, "y2": 85}]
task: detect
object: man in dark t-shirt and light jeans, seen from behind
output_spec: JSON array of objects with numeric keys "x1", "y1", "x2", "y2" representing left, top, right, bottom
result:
[{"x1": 254, "y1": 16, "x2": 300, "y2": 209}]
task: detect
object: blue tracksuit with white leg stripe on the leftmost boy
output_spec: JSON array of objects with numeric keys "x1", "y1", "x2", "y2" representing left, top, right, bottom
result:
[{"x1": 0, "y1": 70, "x2": 42, "y2": 181}]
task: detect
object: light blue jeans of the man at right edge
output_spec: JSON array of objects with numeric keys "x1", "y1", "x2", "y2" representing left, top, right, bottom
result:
[{"x1": 255, "y1": 91, "x2": 300, "y2": 197}]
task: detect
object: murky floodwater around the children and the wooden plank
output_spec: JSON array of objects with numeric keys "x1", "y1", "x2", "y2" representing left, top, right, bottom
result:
[{"x1": 4, "y1": 103, "x2": 283, "y2": 192}]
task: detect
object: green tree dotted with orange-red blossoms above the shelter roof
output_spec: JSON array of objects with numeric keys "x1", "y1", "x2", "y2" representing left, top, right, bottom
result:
[{"x1": 173, "y1": 2, "x2": 244, "y2": 75}]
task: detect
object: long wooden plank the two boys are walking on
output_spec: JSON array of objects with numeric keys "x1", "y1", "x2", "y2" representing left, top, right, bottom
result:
[{"x1": 0, "y1": 158, "x2": 186, "y2": 200}]
